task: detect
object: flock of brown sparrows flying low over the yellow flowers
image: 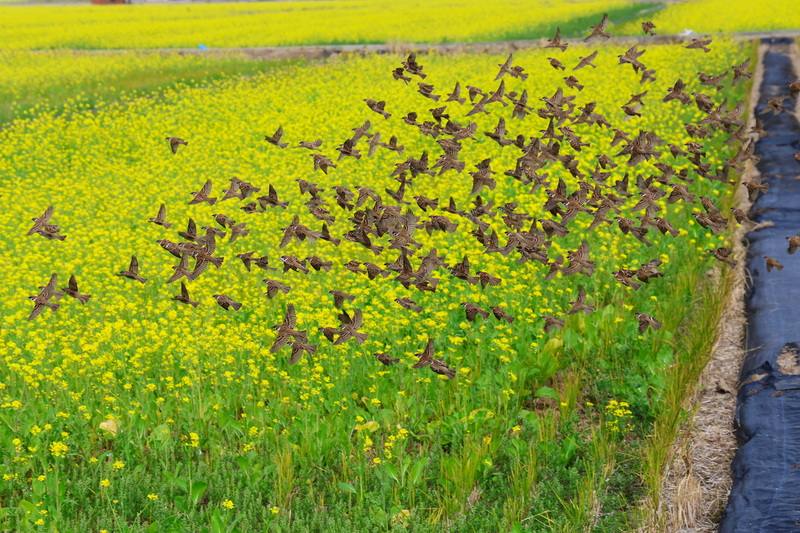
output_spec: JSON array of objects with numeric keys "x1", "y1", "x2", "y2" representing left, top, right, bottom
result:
[{"x1": 21, "y1": 16, "x2": 800, "y2": 378}]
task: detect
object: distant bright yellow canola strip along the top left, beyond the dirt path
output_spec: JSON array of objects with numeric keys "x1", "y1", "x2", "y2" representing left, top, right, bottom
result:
[{"x1": 0, "y1": 0, "x2": 649, "y2": 49}]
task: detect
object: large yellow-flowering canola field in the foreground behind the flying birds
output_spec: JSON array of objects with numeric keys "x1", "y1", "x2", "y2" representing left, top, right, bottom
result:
[{"x1": 0, "y1": 35, "x2": 753, "y2": 532}]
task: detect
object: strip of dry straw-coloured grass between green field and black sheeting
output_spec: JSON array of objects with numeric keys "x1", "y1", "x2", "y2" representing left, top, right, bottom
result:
[{"x1": 648, "y1": 45, "x2": 765, "y2": 533}]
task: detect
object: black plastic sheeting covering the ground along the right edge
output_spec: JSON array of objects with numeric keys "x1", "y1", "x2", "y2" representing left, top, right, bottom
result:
[{"x1": 720, "y1": 40, "x2": 800, "y2": 533}]
